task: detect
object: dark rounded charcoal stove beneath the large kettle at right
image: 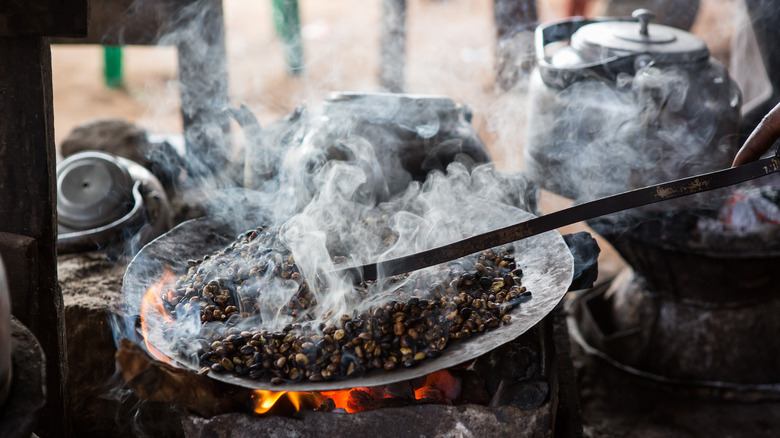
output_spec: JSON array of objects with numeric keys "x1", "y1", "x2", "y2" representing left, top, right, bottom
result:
[{"x1": 570, "y1": 207, "x2": 780, "y2": 396}]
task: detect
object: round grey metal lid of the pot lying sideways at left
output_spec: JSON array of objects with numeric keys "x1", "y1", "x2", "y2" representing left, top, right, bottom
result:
[{"x1": 57, "y1": 151, "x2": 133, "y2": 230}]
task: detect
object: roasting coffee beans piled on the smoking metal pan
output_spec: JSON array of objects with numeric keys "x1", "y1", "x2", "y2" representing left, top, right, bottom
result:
[{"x1": 162, "y1": 228, "x2": 531, "y2": 383}]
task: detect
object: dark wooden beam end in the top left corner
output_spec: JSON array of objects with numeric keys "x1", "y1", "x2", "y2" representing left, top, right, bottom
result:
[{"x1": 0, "y1": 0, "x2": 89, "y2": 37}]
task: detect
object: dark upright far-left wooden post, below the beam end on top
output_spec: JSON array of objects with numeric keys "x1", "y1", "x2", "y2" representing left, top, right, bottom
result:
[{"x1": 0, "y1": 37, "x2": 68, "y2": 437}]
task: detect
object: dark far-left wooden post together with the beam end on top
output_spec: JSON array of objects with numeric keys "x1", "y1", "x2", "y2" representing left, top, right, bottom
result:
[{"x1": 0, "y1": 4, "x2": 88, "y2": 437}]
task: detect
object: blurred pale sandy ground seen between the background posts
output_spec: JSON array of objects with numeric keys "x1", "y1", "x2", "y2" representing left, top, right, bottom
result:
[{"x1": 52, "y1": 0, "x2": 740, "y2": 170}]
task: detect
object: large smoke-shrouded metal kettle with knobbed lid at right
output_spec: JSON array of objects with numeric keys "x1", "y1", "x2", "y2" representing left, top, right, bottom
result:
[{"x1": 524, "y1": 9, "x2": 741, "y2": 204}]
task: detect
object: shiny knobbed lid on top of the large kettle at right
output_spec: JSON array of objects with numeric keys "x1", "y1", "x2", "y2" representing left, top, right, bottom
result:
[{"x1": 571, "y1": 9, "x2": 709, "y2": 64}]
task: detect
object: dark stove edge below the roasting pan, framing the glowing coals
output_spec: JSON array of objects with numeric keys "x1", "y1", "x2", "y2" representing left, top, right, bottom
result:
[{"x1": 177, "y1": 312, "x2": 582, "y2": 438}]
